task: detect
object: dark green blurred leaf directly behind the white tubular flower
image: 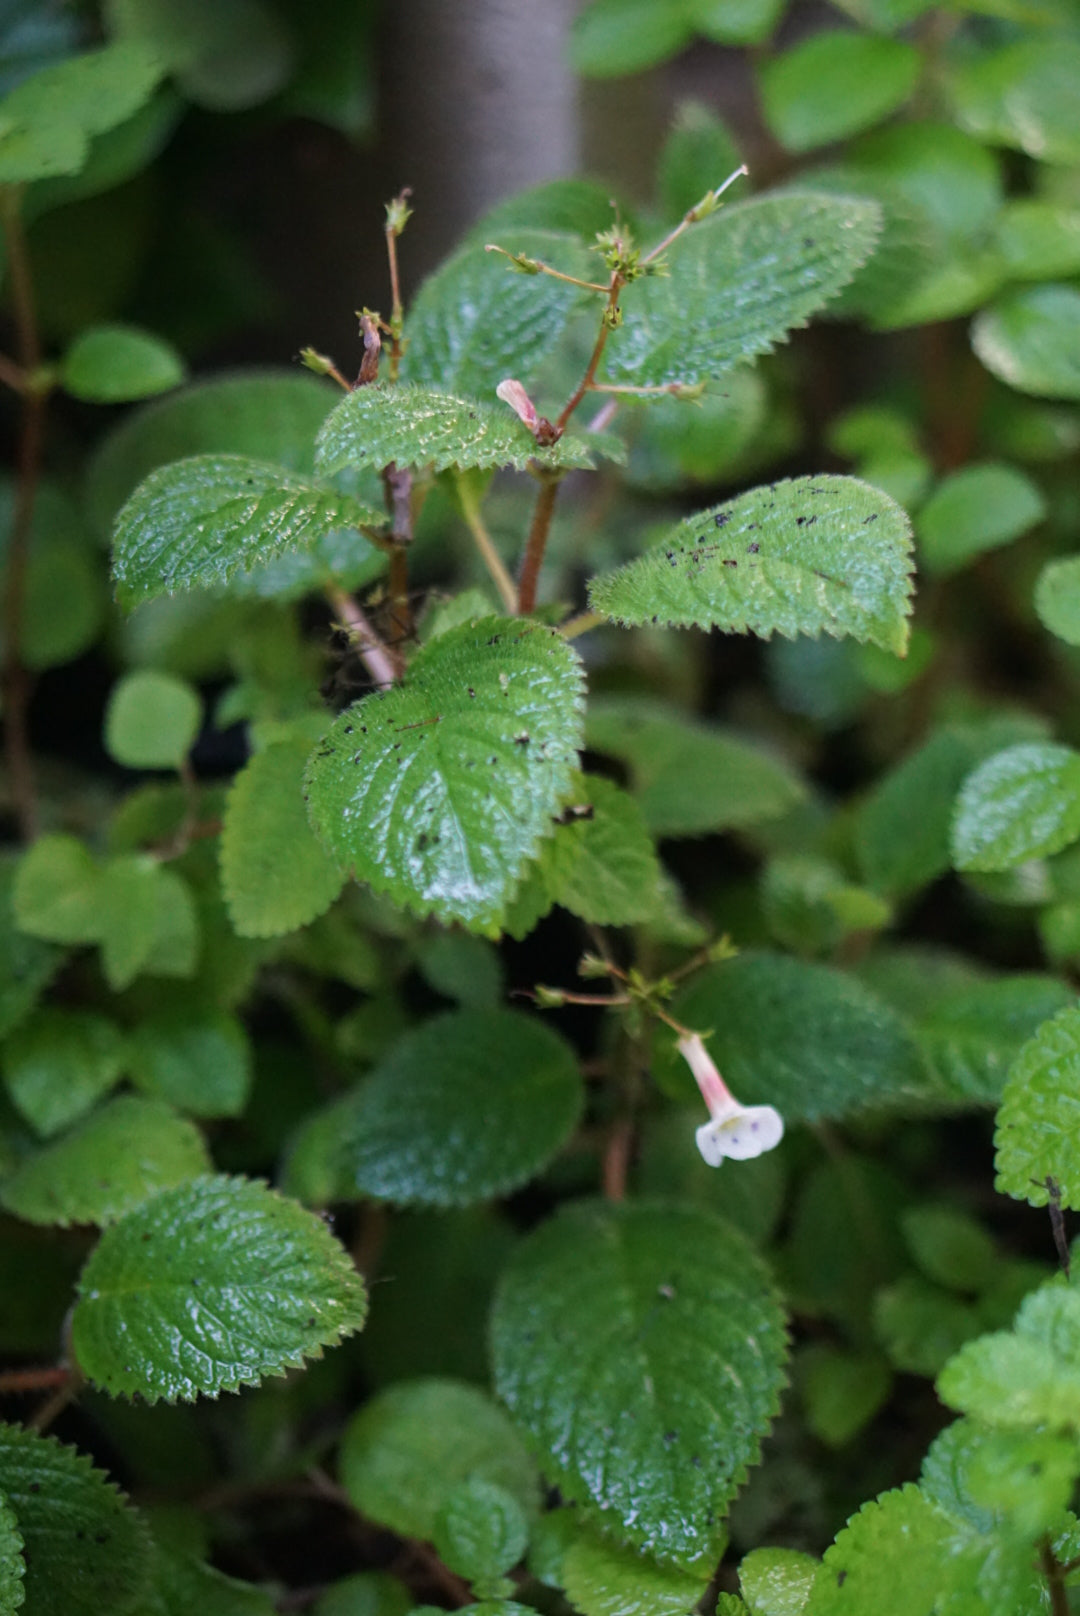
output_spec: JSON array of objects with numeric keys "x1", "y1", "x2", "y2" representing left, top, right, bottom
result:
[{"x1": 656, "y1": 952, "x2": 922, "y2": 1122}]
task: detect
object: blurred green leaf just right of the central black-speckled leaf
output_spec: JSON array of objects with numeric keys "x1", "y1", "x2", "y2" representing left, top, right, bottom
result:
[{"x1": 585, "y1": 696, "x2": 805, "y2": 835}]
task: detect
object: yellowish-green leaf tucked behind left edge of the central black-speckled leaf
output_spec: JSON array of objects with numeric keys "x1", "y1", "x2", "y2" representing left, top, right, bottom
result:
[{"x1": 220, "y1": 737, "x2": 344, "y2": 937}]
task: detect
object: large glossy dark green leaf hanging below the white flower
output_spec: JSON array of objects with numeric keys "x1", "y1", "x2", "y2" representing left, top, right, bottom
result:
[{"x1": 491, "y1": 1202, "x2": 784, "y2": 1561}]
